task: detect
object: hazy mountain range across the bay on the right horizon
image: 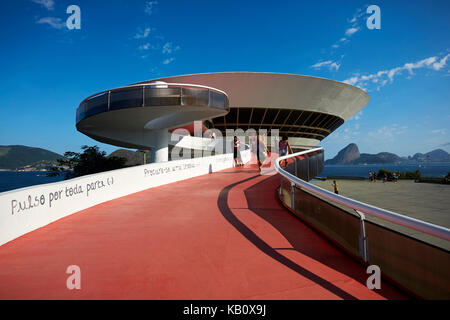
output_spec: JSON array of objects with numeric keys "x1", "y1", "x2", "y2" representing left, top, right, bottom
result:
[{"x1": 325, "y1": 143, "x2": 450, "y2": 165}]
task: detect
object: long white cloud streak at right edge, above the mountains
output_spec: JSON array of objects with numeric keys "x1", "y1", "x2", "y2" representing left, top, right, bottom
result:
[{"x1": 343, "y1": 54, "x2": 450, "y2": 90}]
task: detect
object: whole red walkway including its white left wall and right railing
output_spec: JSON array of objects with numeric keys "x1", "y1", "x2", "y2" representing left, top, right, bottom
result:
[{"x1": 0, "y1": 148, "x2": 450, "y2": 300}]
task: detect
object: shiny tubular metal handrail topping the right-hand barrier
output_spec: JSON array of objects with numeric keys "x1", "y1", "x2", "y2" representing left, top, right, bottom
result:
[{"x1": 275, "y1": 147, "x2": 450, "y2": 241}]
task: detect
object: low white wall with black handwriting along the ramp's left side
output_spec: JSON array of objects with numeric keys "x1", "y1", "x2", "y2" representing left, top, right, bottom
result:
[{"x1": 0, "y1": 150, "x2": 250, "y2": 245}]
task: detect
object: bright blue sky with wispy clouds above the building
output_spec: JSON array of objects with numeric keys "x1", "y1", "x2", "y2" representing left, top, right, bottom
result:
[{"x1": 0, "y1": 0, "x2": 450, "y2": 158}]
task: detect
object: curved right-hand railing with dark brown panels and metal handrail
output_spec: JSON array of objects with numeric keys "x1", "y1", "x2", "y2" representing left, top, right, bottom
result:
[{"x1": 275, "y1": 148, "x2": 450, "y2": 299}]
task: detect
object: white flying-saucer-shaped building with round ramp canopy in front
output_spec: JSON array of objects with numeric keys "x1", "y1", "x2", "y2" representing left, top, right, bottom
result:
[{"x1": 76, "y1": 72, "x2": 369, "y2": 162}]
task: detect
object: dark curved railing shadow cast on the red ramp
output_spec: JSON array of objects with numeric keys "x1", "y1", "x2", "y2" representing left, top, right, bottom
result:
[{"x1": 217, "y1": 175, "x2": 403, "y2": 300}]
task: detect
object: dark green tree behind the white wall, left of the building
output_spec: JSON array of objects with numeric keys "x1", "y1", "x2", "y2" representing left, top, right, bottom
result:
[{"x1": 58, "y1": 145, "x2": 127, "y2": 179}]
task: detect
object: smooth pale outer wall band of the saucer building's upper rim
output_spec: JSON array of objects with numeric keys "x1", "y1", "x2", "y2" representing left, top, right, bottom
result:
[{"x1": 136, "y1": 72, "x2": 370, "y2": 121}]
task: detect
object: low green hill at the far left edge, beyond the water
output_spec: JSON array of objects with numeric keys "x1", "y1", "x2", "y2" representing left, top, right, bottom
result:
[{"x1": 0, "y1": 145, "x2": 63, "y2": 170}]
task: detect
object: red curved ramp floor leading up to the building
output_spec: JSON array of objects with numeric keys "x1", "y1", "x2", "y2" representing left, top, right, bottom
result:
[{"x1": 0, "y1": 167, "x2": 405, "y2": 299}]
